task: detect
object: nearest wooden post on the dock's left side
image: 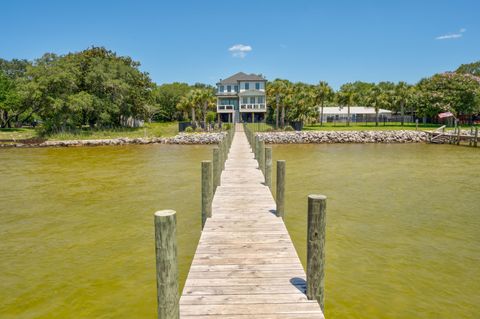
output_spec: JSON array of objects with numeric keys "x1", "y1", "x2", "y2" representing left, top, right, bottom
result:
[{"x1": 154, "y1": 210, "x2": 180, "y2": 319}]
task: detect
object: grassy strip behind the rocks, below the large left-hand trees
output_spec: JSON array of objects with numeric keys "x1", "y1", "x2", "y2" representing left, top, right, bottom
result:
[{"x1": 0, "y1": 122, "x2": 178, "y2": 140}]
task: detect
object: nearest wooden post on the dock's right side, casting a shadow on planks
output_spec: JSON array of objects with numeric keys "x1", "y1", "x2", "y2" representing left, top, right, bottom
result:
[{"x1": 307, "y1": 195, "x2": 327, "y2": 311}]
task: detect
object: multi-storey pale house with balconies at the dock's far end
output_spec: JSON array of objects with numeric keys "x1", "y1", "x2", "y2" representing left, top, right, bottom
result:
[{"x1": 216, "y1": 72, "x2": 267, "y2": 123}]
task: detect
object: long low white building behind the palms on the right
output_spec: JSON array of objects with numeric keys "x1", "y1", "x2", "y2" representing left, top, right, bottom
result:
[{"x1": 318, "y1": 106, "x2": 392, "y2": 123}]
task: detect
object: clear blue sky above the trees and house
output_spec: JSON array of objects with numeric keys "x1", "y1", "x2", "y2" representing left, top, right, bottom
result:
[{"x1": 0, "y1": 0, "x2": 480, "y2": 88}]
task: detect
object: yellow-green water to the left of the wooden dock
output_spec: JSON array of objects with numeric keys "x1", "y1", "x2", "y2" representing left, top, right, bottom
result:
[{"x1": 0, "y1": 145, "x2": 211, "y2": 319}]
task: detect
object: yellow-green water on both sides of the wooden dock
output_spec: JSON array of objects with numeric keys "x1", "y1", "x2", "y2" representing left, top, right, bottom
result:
[{"x1": 0, "y1": 145, "x2": 480, "y2": 318}]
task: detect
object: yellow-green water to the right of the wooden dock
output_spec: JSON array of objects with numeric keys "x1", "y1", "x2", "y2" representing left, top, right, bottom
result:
[{"x1": 273, "y1": 144, "x2": 480, "y2": 319}]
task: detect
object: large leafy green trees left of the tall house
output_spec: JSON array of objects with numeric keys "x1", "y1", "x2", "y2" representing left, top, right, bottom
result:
[{"x1": 0, "y1": 47, "x2": 214, "y2": 133}]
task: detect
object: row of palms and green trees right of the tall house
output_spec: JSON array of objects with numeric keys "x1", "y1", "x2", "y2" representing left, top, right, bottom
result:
[{"x1": 267, "y1": 61, "x2": 480, "y2": 126}]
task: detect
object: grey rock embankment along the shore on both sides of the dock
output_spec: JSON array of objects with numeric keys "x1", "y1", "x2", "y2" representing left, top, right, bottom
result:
[{"x1": 0, "y1": 130, "x2": 427, "y2": 148}]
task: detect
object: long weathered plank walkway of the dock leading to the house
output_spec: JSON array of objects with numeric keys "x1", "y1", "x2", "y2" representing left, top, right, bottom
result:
[{"x1": 180, "y1": 124, "x2": 324, "y2": 319}]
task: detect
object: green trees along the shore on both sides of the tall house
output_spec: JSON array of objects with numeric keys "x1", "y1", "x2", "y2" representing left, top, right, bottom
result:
[{"x1": 0, "y1": 47, "x2": 480, "y2": 133}]
